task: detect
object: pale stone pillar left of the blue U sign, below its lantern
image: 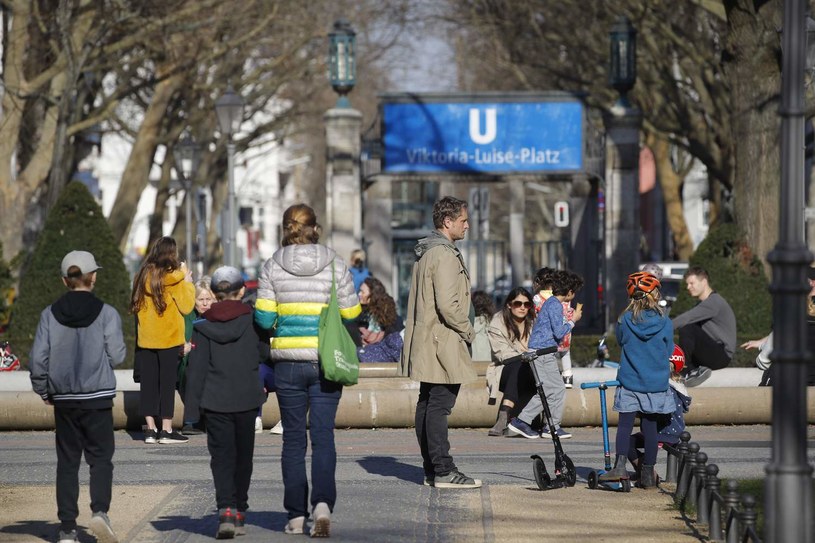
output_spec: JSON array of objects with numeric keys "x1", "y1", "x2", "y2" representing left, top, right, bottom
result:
[{"x1": 322, "y1": 108, "x2": 362, "y2": 261}]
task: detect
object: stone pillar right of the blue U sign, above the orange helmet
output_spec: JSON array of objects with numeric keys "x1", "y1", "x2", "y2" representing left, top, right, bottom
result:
[{"x1": 605, "y1": 104, "x2": 642, "y2": 324}]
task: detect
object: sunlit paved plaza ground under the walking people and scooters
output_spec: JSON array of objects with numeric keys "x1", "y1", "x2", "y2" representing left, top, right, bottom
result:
[{"x1": 0, "y1": 426, "x2": 815, "y2": 543}]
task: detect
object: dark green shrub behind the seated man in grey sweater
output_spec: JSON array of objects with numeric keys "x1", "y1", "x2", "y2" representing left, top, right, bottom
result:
[{"x1": 671, "y1": 224, "x2": 772, "y2": 344}]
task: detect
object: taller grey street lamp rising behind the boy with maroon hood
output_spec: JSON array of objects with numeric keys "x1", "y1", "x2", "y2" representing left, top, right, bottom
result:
[{"x1": 215, "y1": 84, "x2": 243, "y2": 267}]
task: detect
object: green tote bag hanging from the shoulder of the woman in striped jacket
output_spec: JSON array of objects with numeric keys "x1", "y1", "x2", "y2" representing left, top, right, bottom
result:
[{"x1": 317, "y1": 261, "x2": 359, "y2": 385}]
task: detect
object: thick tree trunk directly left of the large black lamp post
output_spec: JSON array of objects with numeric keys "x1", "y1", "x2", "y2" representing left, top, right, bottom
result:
[{"x1": 725, "y1": 0, "x2": 784, "y2": 266}]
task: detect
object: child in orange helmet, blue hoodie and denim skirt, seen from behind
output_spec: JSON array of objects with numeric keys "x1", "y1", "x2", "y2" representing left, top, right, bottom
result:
[{"x1": 600, "y1": 272, "x2": 676, "y2": 488}]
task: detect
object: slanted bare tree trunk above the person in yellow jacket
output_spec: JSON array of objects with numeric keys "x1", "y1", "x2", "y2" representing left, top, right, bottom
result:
[{"x1": 109, "y1": 69, "x2": 184, "y2": 252}]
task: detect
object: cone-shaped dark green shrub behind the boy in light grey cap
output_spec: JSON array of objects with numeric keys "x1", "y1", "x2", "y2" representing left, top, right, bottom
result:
[{"x1": 9, "y1": 182, "x2": 135, "y2": 366}]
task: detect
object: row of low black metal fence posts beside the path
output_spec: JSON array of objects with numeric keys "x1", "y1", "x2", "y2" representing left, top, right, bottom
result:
[{"x1": 663, "y1": 432, "x2": 761, "y2": 543}]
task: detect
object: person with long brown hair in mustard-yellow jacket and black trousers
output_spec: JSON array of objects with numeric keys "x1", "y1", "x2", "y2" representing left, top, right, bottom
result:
[{"x1": 130, "y1": 236, "x2": 195, "y2": 444}]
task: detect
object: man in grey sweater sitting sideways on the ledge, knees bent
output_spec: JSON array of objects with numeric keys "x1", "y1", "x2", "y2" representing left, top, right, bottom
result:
[{"x1": 673, "y1": 266, "x2": 736, "y2": 387}]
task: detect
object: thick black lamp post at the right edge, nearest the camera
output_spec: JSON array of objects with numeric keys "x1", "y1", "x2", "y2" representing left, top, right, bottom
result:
[{"x1": 764, "y1": 0, "x2": 814, "y2": 543}]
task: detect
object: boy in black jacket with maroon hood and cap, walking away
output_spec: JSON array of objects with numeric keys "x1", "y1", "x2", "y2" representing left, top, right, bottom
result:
[{"x1": 187, "y1": 266, "x2": 269, "y2": 539}]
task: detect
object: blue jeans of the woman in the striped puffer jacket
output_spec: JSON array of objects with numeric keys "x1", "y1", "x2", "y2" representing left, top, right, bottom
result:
[{"x1": 274, "y1": 362, "x2": 342, "y2": 519}]
